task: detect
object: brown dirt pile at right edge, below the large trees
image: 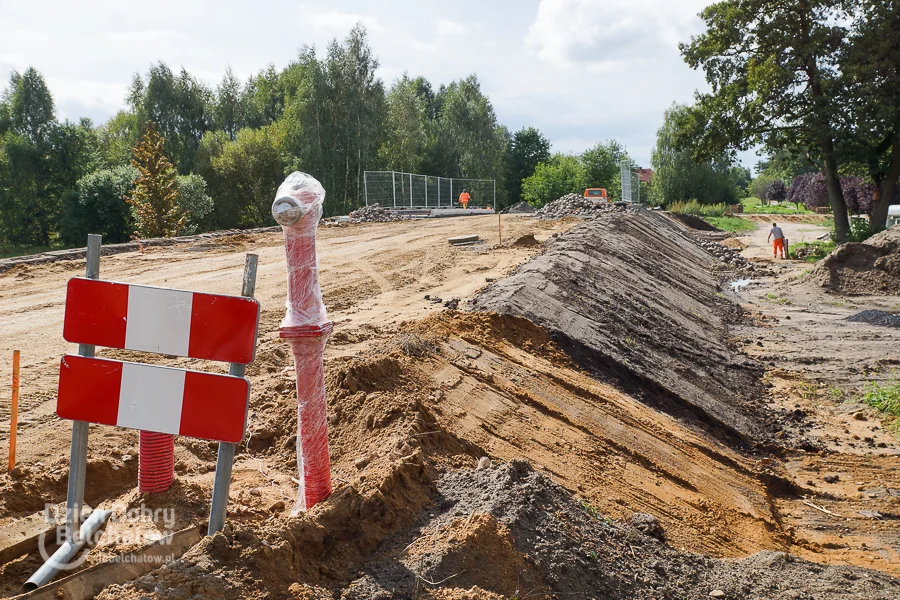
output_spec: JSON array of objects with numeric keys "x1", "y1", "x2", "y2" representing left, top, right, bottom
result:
[{"x1": 804, "y1": 227, "x2": 900, "y2": 296}]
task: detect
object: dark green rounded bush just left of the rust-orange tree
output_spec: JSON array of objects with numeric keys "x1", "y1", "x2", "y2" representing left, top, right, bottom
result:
[{"x1": 60, "y1": 165, "x2": 140, "y2": 245}]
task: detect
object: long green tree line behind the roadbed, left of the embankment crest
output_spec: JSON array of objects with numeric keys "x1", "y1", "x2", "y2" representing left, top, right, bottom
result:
[{"x1": 0, "y1": 25, "x2": 592, "y2": 248}]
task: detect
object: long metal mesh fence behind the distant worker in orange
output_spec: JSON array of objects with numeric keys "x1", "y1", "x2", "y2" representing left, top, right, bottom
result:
[{"x1": 363, "y1": 171, "x2": 497, "y2": 208}]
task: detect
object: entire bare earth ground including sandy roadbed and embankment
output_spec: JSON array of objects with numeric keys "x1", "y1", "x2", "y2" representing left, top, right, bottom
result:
[{"x1": 0, "y1": 213, "x2": 900, "y2": 599}]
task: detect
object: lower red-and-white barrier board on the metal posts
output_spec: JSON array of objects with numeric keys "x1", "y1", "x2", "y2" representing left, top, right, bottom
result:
[{"x1": 56, "y1": 355, "x2": 250, "y2": 443}]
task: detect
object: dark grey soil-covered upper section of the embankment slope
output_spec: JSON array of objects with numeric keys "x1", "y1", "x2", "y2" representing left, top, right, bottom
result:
[{"x1": 473, "y1": 211, "x2": 773, "y2": 443}]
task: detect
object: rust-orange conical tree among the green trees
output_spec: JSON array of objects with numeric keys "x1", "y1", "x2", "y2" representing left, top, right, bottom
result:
[{"x1": 127, "y1": 123, "x2": 188, "y2": 239}]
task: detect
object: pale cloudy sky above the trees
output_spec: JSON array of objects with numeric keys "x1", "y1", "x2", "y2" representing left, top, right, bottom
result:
[{"x1": 0, "y1": 0, "x2": 755, "y2": 166}]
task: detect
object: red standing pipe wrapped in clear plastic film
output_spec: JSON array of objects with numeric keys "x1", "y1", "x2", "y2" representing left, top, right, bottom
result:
[{"x1": 272, "y1": 172, "x2": 332, "y2": 515}]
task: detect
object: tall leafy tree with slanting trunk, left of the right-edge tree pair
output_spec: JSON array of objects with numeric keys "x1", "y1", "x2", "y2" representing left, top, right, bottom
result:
[{"x1": 681, "y1": 0, "x2": 850, "y2": 241}]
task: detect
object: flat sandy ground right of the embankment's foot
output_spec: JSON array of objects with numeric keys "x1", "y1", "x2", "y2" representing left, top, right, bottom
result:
[{"x1": 734, "y1": 223, "x2": 900, "y2": 571}]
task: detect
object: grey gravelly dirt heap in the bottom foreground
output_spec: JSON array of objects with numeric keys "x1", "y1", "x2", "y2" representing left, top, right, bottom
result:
[{"x1": 326, "y1": 461, "x2": 900, "y2": 600}]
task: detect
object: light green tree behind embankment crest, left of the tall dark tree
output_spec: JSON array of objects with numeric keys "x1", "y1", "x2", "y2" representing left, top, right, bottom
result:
[{"x1": 651, "y1": 105, "x2": 738, "y2": 204}]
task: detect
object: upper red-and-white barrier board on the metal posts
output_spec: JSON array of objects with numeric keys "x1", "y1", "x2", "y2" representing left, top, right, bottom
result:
[{"x1": 63, "y1": 278, "x2": 259, "y2": 364}]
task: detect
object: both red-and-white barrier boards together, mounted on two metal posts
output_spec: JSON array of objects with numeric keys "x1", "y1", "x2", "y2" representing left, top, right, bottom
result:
[{"x1": 56, "y1": 278, "x2": 259, "y2": 443}]
